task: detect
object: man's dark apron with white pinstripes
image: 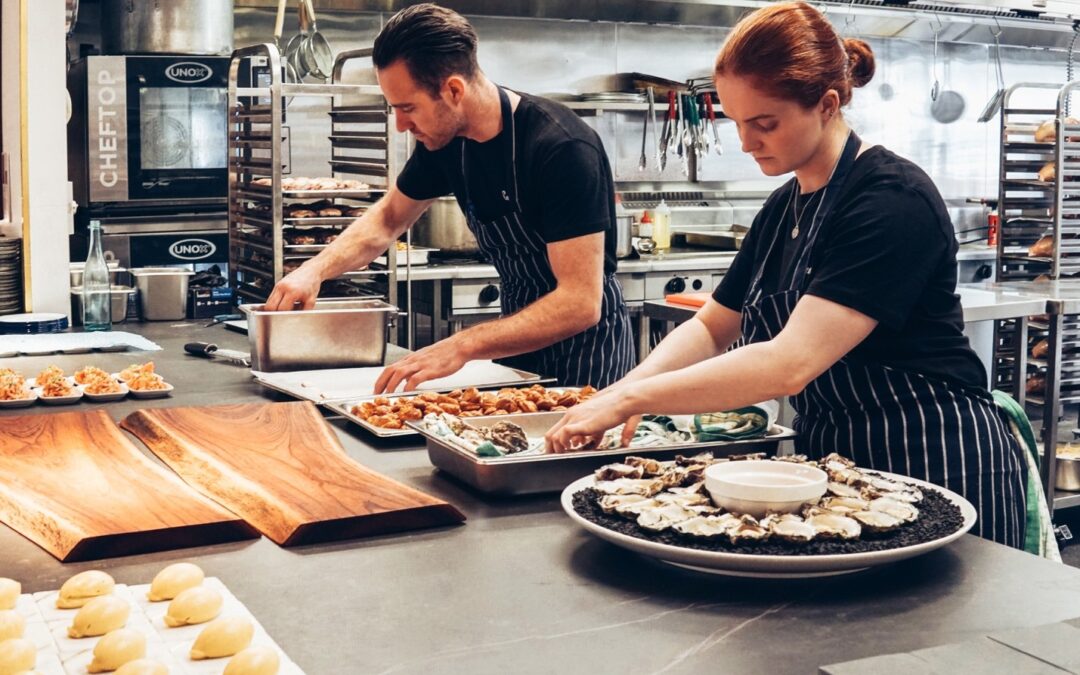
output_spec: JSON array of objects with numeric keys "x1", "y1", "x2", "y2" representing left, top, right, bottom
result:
[{"x1": 458, "y1": 87, "x2": 634, "y2": 389}]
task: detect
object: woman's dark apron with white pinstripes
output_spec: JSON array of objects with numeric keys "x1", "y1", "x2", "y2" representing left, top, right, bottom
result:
[{"x1": 742, "y1": 134, "x2": 1026, "y2": 548}]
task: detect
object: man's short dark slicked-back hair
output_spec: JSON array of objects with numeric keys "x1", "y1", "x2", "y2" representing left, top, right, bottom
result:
[{"x1": 372, "y1": 2, "x2": 480, "y2": 97}]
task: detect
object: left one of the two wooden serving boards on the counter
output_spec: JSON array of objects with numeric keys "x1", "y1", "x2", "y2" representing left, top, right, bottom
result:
[{"x1": 0, "y1": 410, "x2": 258, "y2": 563}]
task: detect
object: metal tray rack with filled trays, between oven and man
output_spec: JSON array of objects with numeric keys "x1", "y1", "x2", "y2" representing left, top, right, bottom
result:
[{"x1": 228, "y1": 43, "x2": 407, "y2": 319}]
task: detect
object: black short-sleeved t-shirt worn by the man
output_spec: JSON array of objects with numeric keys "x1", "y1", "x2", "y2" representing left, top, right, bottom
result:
[{"x1": 397, "y1": 94, "x2": 616, "y2": 274}]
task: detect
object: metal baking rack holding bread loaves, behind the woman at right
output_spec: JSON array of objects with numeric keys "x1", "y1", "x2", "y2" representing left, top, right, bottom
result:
[{"x1": 991, "y1": 82, "x2": 1080, "y2": 509}]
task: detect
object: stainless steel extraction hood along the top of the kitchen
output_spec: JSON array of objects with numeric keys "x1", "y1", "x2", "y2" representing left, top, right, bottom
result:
[{"x1": 235, "y1": 0, "x2": 1080, "y2": 50}]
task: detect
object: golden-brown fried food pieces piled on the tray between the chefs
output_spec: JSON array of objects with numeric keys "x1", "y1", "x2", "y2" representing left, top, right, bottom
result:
[{"x1": 351, "y1": 384, "x2": 596, "y2": 429}]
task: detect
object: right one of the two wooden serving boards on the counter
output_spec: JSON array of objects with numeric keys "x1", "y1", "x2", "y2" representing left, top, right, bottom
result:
[{"x1": 121, "y1": 401, "x2": 464, "y2": 545}]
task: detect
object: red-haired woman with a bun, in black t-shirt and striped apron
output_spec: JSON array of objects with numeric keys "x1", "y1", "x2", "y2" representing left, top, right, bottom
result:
[{"x1": 548, "y1": 2, "x2": 1025, "y2": 548}]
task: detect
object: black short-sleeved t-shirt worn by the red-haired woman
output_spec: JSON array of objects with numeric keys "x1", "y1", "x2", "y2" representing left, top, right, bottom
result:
[{"x1": 713, "y1": 146, "x2": 986, "y2": 390}]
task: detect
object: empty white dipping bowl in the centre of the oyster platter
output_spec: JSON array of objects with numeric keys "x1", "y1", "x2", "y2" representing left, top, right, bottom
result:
[{"x1": 705, "y1": 460, "x2": 828, "y2": 518}]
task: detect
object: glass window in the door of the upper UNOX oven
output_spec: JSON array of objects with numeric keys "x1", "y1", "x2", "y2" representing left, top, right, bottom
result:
[{"x1": 139, "y1": 87, "x2": 228, "y2": 171}]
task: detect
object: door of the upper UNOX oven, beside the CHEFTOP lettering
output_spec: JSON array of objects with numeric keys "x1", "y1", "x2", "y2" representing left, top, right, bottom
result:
[{"x1": 126, "y1": 56, "x2": 229, "y2": 202}]
